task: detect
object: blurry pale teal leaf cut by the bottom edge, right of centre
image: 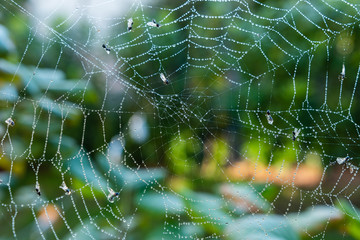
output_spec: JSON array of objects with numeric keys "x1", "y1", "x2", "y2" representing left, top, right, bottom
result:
[{"x1": 225, "y1": 214, "x2": 300, "y2": 240}]
